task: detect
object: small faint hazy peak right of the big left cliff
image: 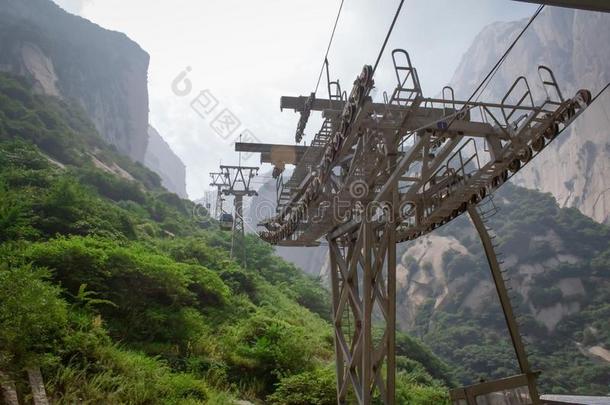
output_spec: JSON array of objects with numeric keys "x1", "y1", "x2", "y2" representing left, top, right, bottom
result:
[{"x1": 144, "y1": 126, "x2": 188, "y2": 198}]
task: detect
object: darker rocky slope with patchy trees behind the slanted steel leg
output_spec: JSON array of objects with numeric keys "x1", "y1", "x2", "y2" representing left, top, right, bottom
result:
[{"x1": 397, "y1": 184, "x2": 610, "y2": 395}]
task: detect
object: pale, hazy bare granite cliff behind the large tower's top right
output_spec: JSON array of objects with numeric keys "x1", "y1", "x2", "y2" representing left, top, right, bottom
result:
[{"x1": 452, "y1": 7, "x2": 610, "y2": 222}]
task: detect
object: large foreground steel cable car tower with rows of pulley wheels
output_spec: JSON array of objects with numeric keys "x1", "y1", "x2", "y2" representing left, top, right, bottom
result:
[{"x1": 236, "y1": 49, "x2": 591, "y2": 405}]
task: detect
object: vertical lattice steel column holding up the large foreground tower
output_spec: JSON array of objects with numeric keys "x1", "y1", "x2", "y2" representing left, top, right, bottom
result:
[{"x1": 328, "y1": 213, "x2": 396, "y2": 405}]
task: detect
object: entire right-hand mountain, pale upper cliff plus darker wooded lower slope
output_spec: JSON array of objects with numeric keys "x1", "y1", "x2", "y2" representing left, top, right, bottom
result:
[{"x1": 397, "y1": 7, "x2": 610, "y2": 395}]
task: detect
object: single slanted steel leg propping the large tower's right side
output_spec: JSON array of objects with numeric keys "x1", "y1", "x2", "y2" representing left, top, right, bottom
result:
[{"x1": 468, "y1": 204, "x2": 540, "y2": 405}]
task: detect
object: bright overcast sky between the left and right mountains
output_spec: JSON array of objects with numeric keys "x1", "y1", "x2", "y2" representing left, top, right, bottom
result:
[{"x1": 56, "y1": 0, "x2": 536, "y2": 198}]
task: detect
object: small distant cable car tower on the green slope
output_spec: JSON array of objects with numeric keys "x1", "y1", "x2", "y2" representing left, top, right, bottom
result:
[{"x1": 220, "y1": 164, "x2": 259, "y2": 267}]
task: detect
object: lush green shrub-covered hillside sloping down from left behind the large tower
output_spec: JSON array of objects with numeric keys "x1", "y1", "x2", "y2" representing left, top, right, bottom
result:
[{"x1": 0, "y1": 75, "x2": 451, "y2": 405}]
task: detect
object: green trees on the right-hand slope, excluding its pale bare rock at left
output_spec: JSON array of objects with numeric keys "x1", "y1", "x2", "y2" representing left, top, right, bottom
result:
[{"x1": 413, "y1": 184, "x2": 610, "y2": 395}]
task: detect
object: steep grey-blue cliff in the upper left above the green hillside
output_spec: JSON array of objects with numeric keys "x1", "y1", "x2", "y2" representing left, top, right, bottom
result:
[{"x1": 0, "y1": 0, "x2": 149, "y2": 161}]
